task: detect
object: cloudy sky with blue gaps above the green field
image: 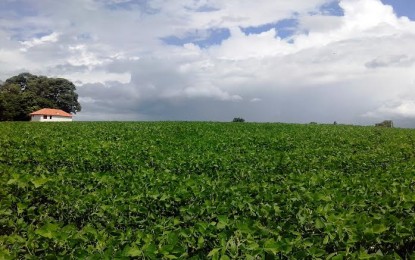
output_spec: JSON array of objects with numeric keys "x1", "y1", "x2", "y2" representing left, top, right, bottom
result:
[{"x1": 0, "y1": 0, "x2": 415, "y2": 127}]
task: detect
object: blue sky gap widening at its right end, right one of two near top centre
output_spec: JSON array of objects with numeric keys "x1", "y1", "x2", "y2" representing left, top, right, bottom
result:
[{"x1": 242, "y1": 19, "x2": 298, "y2": 39}]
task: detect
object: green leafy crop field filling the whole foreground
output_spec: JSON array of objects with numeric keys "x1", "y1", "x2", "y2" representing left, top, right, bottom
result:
[{"x1": 0, "y1": 122, "x2": 415, "y2": 259}]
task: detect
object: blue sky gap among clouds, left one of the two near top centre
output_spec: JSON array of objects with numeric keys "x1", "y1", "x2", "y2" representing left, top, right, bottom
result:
[{"x1": 161, "y1": 28, "x2": 231, "y2": 48}]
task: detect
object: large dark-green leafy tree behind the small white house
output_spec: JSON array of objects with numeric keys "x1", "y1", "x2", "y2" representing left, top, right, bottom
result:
[{"x1": 0, "y1": 73, "x2": 81, "y2": 121}]
